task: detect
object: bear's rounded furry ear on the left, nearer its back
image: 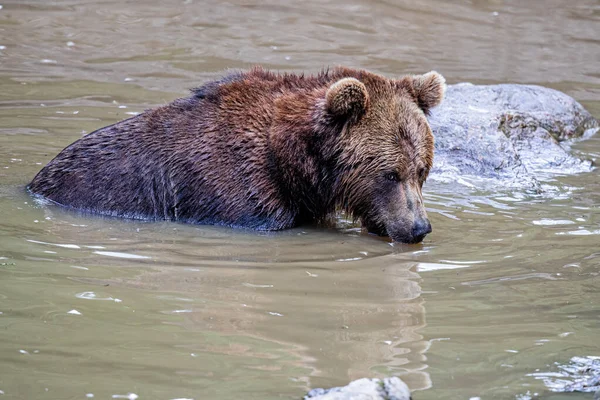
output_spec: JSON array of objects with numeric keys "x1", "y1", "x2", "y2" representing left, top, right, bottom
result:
[{"x1": 325, "y1": 78, "x2": 369, "y2": 120}]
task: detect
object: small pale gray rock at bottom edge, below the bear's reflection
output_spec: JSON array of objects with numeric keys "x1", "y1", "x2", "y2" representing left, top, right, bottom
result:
[{"x1": 304, "y1": 377, "x2": 410, "y2": 400}]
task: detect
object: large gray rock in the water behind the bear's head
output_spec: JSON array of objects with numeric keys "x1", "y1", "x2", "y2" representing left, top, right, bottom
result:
[{"x1": 429, "y1": 83, "x2": 599, "y2": 189}]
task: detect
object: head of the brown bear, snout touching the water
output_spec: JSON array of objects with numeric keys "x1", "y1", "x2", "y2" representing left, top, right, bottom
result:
[{"x1": 323, "y1": 71, "x2": 446, "y2": 243}]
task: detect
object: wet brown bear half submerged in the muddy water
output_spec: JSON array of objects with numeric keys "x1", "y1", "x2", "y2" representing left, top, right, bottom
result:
[{"x1": 29, "y1": 67, "x2": 445, "y2": 243}]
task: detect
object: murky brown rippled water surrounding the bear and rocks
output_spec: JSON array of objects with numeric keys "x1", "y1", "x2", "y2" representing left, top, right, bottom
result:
[{"x1": 0, "y1": 0, "x2": 600, "y2": 399}]
